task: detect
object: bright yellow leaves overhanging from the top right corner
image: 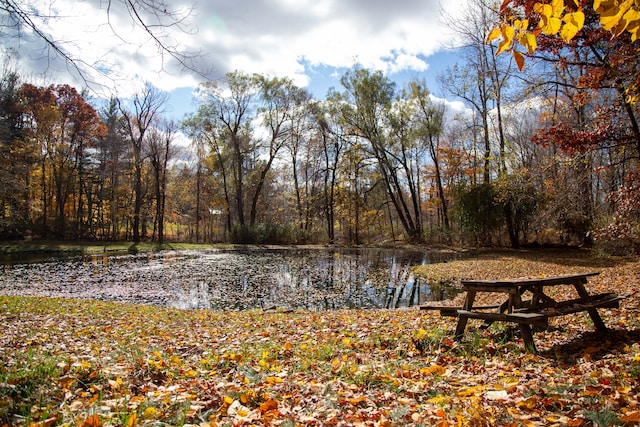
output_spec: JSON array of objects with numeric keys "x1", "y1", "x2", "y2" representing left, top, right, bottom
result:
[{"x1": 487, "y1": 0, "x2": 640, "y2": 71}]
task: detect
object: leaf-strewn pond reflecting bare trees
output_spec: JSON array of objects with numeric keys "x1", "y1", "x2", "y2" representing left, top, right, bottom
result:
[{"x1": 0, "y1": 248, "x2": 457, "y2": 311}]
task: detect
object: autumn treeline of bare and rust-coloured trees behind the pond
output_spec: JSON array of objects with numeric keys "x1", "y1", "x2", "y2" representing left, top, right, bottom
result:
[{"x1": 0, "y1": 0, "x2": 640, "y2": 248}]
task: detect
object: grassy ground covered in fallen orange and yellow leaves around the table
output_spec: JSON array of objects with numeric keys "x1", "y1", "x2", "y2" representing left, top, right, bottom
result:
[{"x1": 0, "y1": 251, "x2": 640, "y2": 427}]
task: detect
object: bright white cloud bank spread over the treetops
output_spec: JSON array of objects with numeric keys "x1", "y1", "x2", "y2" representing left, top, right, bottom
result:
[{"x1": 5, "y1": 0, "x2": 460, "y2": 98}]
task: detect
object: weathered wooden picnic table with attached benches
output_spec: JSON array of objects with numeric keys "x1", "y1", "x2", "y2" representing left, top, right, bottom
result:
[{"x1": 421, "y1": 272, "x2": 629, "y2": 351}]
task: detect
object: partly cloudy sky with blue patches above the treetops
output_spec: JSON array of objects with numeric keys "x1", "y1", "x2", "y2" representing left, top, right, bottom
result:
[{"x1": 0, "y1": 0, "x2": 464, "y2": 119}]
